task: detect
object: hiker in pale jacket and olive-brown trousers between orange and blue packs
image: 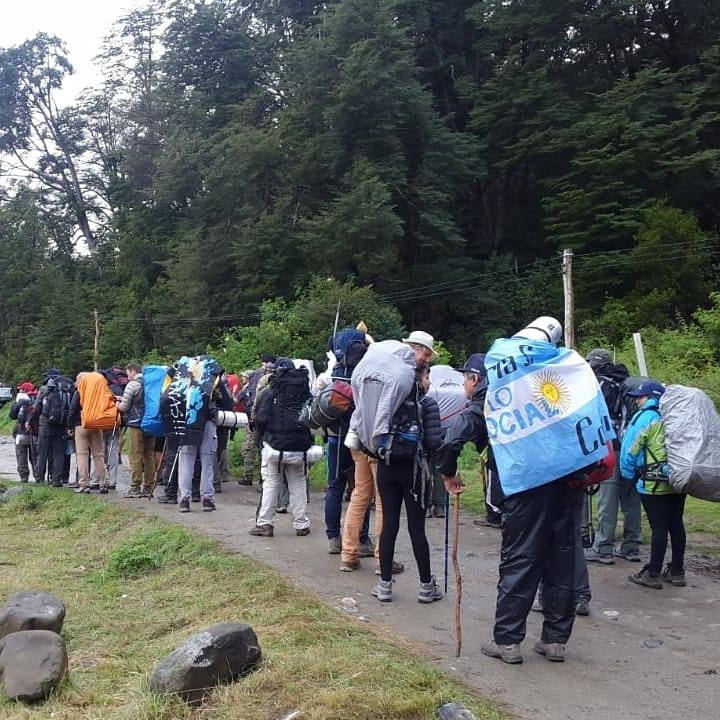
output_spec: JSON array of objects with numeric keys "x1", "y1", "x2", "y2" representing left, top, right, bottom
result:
[{"x1": 117, "y1": 363, "x2": 155, "y2": 498}]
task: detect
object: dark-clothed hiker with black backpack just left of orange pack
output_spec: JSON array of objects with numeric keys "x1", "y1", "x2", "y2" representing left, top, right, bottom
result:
[{"x1": 30, "y1": 368, "x2": 75, "y2": 487}]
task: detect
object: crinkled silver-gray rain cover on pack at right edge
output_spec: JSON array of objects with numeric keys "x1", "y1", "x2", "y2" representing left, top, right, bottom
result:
[{"x1": 660, "y1": 385, "x2": 720, "y2": 502}]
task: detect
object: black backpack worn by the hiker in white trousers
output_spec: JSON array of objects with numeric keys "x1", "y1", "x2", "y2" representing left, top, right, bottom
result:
[{"x1": 257, "y1": 368, "x2": 312, "y2": 452}]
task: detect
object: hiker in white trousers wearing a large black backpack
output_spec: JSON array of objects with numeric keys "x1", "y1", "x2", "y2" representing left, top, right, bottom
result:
[{"x1": 250, "y1": 357, "x2": 312, "y2": 537}]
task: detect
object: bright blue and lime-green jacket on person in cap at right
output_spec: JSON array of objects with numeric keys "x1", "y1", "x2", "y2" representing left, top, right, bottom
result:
[{"x1": 620, "y1": 398, "x2": 675, "y2": 495}]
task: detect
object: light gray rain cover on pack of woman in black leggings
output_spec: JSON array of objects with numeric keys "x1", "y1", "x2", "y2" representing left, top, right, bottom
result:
[{"x1": 350, "y1": 340, "x2": 415, "y2": 453}]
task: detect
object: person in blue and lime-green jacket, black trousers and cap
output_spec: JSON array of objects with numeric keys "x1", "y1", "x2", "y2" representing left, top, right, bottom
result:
[{"x1": 620, "y1": 380, "x2": 686, "y2": 590}]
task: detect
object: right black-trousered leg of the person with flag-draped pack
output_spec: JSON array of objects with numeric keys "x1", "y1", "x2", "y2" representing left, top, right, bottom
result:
[{"x1": 542, "y1": 481, "x2": 589, "y2": 644}]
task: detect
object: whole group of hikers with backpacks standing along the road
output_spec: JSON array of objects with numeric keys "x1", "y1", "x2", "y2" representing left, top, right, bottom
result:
[{"x1": 11, "y1": 317, "x2": 704, "y2": 664}]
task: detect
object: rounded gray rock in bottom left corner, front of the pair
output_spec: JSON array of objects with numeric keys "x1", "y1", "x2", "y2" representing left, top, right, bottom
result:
[{"x1": 0, "y1": 630, "x2": 67, "y2": 702}]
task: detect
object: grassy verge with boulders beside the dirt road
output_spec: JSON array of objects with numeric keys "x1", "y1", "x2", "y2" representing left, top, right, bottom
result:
[{"x1": 0, "y1": 487, "x2": 505, "y2": 720}]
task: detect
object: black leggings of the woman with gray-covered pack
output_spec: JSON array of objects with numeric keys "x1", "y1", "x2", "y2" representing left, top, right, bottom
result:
[{"x1": 377, "y1": 460, "x2": 432, "y2": 583}]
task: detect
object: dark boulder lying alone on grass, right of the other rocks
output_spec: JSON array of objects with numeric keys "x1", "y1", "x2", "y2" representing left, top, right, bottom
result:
[{"x1": 150, "y1": 623, "x2": 261, "y2": 702}]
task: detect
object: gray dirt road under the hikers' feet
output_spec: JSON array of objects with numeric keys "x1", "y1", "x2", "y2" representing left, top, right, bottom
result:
[{"x1": 0, "y1": 438, "x2": 720, "y2": 720}]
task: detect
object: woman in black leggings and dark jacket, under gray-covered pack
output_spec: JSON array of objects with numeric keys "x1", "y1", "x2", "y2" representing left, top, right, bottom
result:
[{"x1": 372, "y1": 362, "x2": 443, "y2": 603}]
